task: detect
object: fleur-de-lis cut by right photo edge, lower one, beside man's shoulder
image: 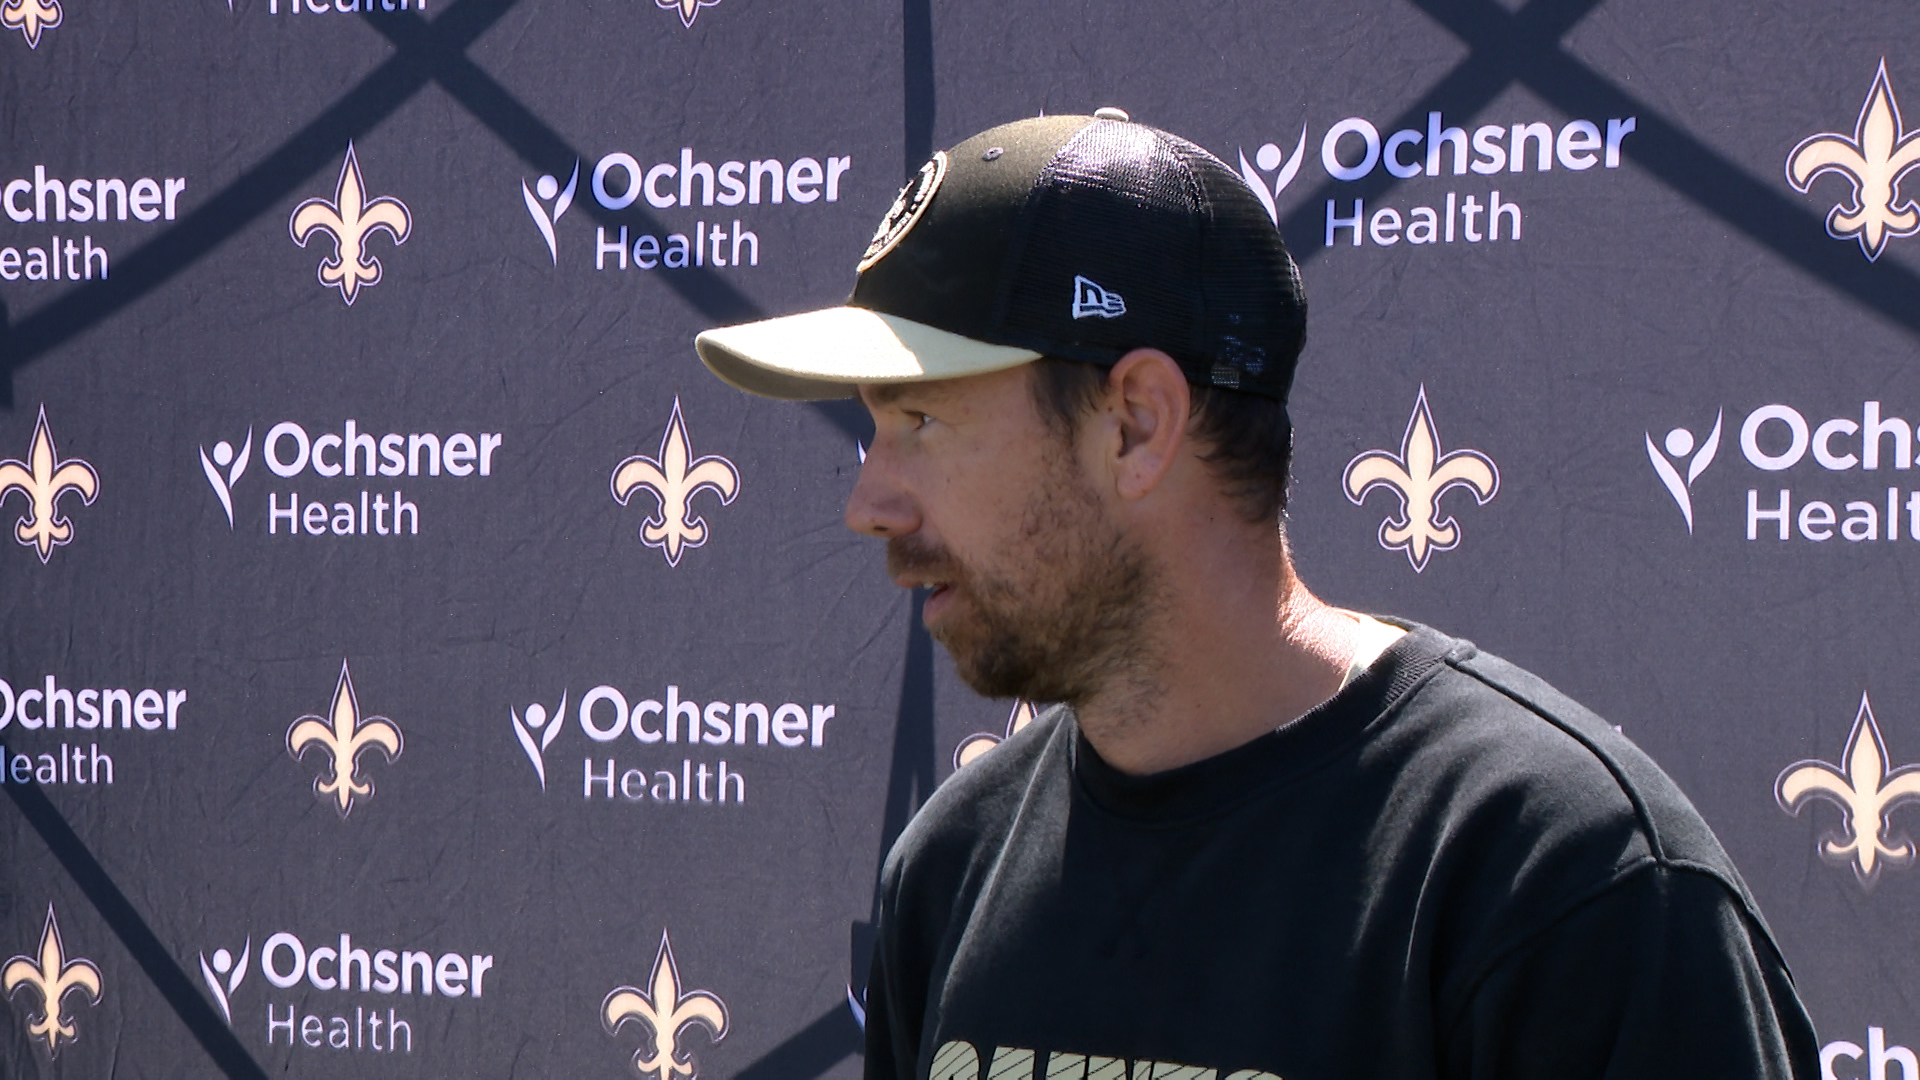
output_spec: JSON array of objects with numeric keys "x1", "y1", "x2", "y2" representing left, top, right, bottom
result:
[{"x1": 1774, "y1": 694, "x2": 1920, "y2": 888}]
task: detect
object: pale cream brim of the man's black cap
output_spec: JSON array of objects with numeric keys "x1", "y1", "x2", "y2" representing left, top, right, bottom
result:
[{"x1": 693, "y1": 307, "x2": 1041, "y2": 402}]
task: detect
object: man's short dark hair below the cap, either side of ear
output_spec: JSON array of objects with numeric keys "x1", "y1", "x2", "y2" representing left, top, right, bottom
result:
[{"x1": 1033, "y1": 356, "x2": 1294, "y2": 523}]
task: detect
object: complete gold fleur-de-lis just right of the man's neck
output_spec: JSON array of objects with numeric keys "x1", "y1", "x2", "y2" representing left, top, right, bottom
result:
[{"x1": 1342, "y1": 386, "x2": 1500, "y2": 573}]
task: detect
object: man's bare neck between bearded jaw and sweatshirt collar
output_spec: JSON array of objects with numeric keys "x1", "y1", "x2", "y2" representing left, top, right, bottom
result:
[{"x1": 1075, "y1": 546, "x2": 1357, "y2": 774}]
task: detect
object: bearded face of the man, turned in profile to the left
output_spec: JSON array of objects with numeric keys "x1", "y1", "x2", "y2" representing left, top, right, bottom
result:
[{"x1": 847, "y1": 365, "x2": 1154, "y2": 701}]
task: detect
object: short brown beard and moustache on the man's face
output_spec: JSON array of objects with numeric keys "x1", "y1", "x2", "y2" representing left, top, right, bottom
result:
[{"x1": 887, "y1": 441, "x2": 1160, "y2": 705}]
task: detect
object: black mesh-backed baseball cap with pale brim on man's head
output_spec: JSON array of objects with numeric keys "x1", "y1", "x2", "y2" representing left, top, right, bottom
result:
[{"x1": 695, "y1": 110, "x2": 1306, "y2": 404}]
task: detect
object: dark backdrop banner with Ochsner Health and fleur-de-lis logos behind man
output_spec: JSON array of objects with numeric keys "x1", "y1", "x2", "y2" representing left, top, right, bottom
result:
[{"x1": 0, "y1": 0, "x2": 1920, "y2": 1080}]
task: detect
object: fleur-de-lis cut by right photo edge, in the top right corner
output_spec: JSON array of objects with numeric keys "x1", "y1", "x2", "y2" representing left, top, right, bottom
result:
[{"x1": 1788, "y1": 58, "x2": 1920, "y2": 261}]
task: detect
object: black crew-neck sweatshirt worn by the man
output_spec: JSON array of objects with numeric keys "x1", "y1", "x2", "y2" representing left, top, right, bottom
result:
[{"x1": 866, "y1": 626, "x2": 1820, "y2": 1080}]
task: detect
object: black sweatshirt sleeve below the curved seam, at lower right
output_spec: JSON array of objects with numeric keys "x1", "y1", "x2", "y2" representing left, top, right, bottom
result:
[{"x1": 1440, "y1": 865, "x2": 1820, "y2": 1080}]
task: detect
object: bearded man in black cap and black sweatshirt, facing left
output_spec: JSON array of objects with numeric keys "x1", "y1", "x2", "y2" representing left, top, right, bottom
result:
[{"x1": 697, "y1": 110, "x2": 1818, "y2": 1080}]
